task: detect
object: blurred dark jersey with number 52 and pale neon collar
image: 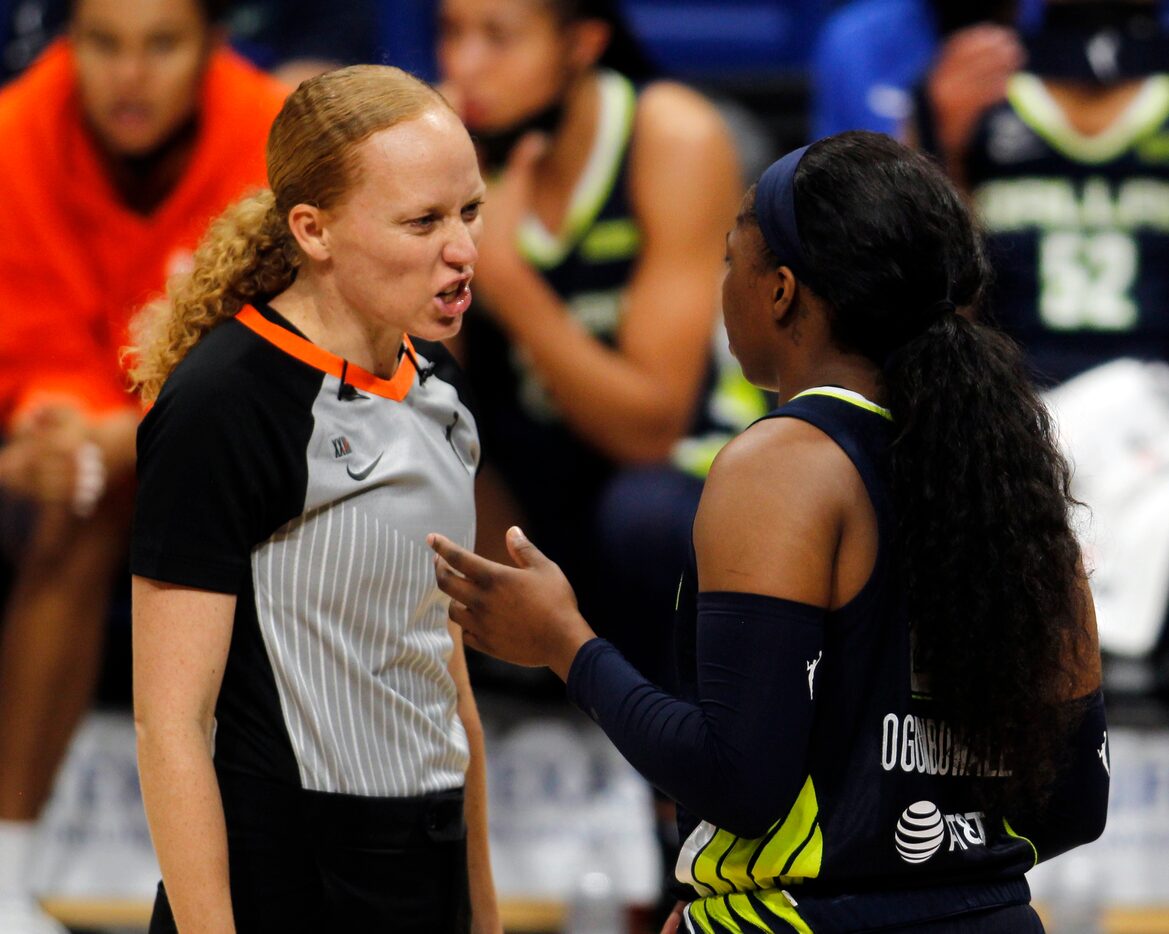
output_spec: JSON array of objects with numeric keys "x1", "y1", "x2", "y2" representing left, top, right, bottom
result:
[{"x1": 966, "y1": 74, "x2": 1169, "y2": 381}]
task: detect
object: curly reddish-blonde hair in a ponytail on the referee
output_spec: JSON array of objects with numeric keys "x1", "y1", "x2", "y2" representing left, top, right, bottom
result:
[{"x1": 130, "y1": 65, "x2": 449, "y2": 402}]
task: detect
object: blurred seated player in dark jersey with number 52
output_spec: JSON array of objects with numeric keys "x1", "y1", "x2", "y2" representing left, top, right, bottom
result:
[{"x1": 926, "y1": 0, "x2": 1169, "y2": 383}]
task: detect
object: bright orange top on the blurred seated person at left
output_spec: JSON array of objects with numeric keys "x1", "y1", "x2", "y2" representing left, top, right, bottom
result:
[{"x1": 0, "y1": 41, "x2": 288, "y2": 426}]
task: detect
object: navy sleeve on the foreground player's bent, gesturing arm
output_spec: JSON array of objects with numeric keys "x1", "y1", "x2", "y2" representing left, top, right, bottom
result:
[{"x1": 568, "y1": 593, "x2": 825, "y2": 838}]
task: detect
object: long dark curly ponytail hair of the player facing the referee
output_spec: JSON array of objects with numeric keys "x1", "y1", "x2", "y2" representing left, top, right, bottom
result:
[{"x1": 752, "y1": 132, "x2": 1087, "y2": 812}]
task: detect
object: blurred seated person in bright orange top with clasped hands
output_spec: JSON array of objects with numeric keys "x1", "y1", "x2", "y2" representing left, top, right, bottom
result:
[{"x1": 0, "y1": 0, "x2": 284, "y2": 934}]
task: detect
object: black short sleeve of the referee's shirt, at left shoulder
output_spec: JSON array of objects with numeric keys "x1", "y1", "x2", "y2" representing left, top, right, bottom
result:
[{"x1": 130, "y1": 362, "x2": 311, "y2": 594}]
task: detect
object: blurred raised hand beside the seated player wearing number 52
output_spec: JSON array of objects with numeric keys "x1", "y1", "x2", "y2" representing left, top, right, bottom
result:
[{"x1": 926, "y1": 22, "x2": 1026, "y2": 168}]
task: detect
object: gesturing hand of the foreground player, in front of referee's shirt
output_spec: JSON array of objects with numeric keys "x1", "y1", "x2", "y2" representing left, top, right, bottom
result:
[{"x1": 427, "y1": 527, "x2": 595, "y2": 679}]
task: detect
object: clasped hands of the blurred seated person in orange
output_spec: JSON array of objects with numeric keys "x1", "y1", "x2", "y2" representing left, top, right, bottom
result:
[{"x1": 0, "y1": 402, "x2": 105, "y2": 516}]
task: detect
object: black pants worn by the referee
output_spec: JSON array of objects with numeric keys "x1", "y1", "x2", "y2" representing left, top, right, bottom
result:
[{"x1": 150, "y1": 774, "x2": 471, "y2": 934}]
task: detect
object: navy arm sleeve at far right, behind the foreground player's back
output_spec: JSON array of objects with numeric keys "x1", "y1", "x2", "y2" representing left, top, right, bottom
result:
[{"x1": 1008, "y1": 690, "x2": 1111, "y2": 863}]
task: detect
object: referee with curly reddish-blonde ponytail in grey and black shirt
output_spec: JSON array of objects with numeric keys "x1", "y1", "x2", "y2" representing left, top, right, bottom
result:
[{"x1": 131, "y1": 65, "x2": 499, "y2": 934}]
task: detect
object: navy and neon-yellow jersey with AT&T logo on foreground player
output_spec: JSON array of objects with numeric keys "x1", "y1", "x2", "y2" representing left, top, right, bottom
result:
[{"x1": 676, "y1": 387, "x2": 1036, "y2": 934}]
